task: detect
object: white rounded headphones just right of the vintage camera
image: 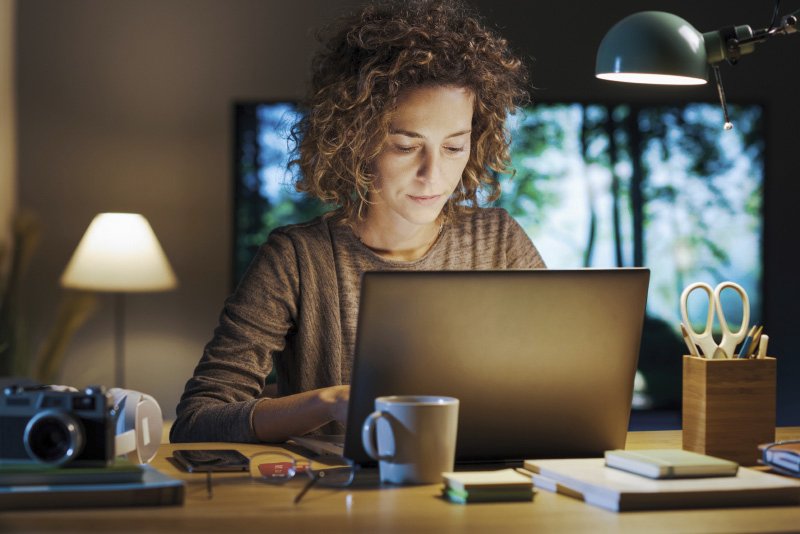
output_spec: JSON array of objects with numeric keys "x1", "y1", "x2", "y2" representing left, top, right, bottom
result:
[{"x1": 108, "y1": 388, "x2": 164, "y2": 464}]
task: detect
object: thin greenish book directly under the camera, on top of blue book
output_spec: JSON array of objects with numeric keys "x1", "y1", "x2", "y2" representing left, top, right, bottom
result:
[{"x1": 0, "y1": 458, "x2": 144, "y2": 486}]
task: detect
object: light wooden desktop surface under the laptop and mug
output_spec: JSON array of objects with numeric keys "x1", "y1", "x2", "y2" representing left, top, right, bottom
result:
[{"x1": 0, "y1": 427, "x2": 800, "y2": 534}]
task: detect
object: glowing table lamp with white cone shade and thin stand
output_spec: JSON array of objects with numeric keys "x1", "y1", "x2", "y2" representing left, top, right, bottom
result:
[{"x1": 61, "y1": 213, "x2": 177, "y2": 387}]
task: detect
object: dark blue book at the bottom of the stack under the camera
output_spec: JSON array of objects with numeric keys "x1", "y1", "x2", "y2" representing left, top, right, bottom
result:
[{"x1": 0, "y1": 465, "x2": 185, "y2": 510}]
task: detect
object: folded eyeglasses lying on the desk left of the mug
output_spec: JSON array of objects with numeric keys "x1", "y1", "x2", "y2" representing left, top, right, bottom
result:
[{"x1": 250, "y1": 452, "x2": 356, "y2": 504}]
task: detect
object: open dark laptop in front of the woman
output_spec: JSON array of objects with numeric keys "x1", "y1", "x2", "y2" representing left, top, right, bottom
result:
[{"x1": 293, "y1": 268, "x2": 650, "y2": 465}]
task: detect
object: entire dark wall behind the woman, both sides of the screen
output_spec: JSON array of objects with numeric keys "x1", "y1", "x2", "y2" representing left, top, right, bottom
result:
[{"x1": 17, "y1": 0, "x2": 800, "y2": 423}]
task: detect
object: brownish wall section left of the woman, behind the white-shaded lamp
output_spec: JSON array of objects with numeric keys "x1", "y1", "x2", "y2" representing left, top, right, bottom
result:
[{"x1": 17, "y1": 0, "x2": 360, "y2": 417}]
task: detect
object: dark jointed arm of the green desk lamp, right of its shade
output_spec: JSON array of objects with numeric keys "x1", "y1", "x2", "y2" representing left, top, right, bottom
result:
[{"x1": 703, "y1": 9, "x2": 800, "y2": 65}]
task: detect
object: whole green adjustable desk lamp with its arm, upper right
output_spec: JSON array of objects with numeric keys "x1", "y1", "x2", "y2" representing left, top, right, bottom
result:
[{"x1": 595, "y1": 1, "x2": 800, "y2": 130}]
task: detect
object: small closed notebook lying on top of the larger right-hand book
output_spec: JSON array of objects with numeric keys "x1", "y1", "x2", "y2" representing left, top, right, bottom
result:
[{"x1": 605, "y1": 449, "x2": 739, "y2": 478}]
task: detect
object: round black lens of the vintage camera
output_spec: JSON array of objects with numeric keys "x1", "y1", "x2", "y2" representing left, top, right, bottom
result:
[{"x1": 22, "y1": 410, "x2": 84, "y2": 465}]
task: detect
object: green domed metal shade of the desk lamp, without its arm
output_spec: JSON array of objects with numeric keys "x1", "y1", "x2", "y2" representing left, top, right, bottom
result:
[{"x1": 595, "y1": 11, "x2": 708, "y2": 85}]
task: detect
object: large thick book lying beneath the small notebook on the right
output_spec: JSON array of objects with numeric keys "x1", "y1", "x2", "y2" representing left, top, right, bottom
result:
[{"x1": 525, "y1": 458, "x2": 800, "y2": 512}]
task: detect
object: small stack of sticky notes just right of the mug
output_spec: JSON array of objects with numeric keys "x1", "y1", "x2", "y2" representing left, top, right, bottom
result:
[{"x1": 442, "y1": 469, "x2": 533, "y2": 504}]
